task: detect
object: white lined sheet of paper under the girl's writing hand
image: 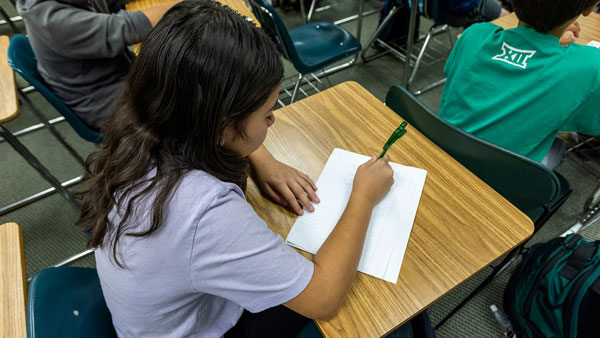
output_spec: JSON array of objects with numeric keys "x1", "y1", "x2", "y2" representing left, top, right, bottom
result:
[{"x1": 286, "y1": 149, "x2": 427, "y2": 283}]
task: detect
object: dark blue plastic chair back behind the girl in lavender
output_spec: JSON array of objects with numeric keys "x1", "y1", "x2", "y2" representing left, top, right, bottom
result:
[{"x1": 27, "y1": 267, "x2": 117, "y2": 338}]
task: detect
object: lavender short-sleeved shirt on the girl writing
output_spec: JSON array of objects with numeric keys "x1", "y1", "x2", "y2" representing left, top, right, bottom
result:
[{"x1": 95, "y1": 171, "x2": 313, "y2": 337}]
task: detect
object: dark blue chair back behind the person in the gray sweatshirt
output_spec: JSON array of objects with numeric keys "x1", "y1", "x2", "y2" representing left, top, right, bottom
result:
[{"x1": 8, "y1": 34, "x2": 102, "y2": 143}]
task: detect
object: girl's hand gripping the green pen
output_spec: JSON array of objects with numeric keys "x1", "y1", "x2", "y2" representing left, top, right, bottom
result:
[{"x1": 352, "y1": 155, "x2": 394, "y2": 205}]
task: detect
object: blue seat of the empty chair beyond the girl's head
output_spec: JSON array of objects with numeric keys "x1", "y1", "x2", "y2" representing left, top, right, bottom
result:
[{"x1": 289, "y1": 22, "x2": 361, "y2": 74}]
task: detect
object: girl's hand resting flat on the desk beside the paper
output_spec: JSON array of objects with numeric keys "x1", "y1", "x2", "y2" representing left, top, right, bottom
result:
[{"x1": 249, "y1": 146, "x2": 320, "y2": 215}]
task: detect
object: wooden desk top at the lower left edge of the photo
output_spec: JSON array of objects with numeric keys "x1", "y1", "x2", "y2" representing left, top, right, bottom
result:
[{"x1": 0, "y1": 223, "x2": 27, "y2": 338}]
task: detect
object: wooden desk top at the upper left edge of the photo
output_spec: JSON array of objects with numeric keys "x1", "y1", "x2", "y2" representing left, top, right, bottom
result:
[{"x1": 0, "y1": 35, "x2": 19, "y2": 124}]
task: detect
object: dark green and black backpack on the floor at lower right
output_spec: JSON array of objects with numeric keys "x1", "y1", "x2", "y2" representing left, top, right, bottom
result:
[{"x1": 504, "y1": 235, "x2": 600, "y2": 338}]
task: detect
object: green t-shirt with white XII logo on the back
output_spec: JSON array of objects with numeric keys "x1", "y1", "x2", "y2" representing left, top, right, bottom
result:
[{"x1": 440, "y1": 23, "x2": 600, "y2": 161}]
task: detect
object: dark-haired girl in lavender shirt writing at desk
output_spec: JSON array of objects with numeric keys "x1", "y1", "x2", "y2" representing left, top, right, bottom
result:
[{"x1": 78, "y1": 0, "x2": 393, "y2": 337}]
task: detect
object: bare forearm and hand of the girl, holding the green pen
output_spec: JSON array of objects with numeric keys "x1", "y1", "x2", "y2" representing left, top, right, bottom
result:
[{"x1": 284, "y1": 156, "x2": 394, "y2": 320}]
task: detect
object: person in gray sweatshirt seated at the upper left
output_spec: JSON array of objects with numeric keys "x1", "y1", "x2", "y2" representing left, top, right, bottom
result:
[{"x1": 16, "y1": 0, "x2": 172, "y2": 130}]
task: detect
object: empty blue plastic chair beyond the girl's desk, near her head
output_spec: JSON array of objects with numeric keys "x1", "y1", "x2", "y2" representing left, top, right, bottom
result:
[{"x1": 250, "y1": 0, "x2": 361, "y2": 103}]
